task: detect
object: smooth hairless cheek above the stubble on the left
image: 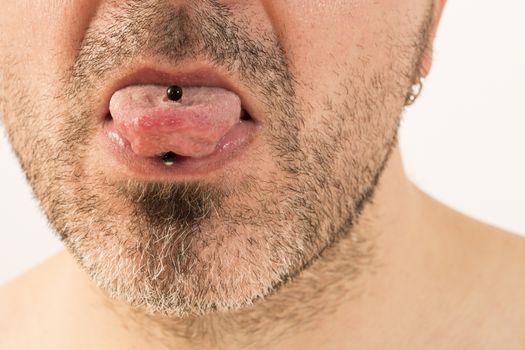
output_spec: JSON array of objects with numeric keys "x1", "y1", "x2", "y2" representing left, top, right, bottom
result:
[{"x1": 0, "y1": 0, "x2": 99, "y2": 95}]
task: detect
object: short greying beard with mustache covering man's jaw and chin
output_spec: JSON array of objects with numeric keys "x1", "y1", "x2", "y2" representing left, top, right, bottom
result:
[{"x1": 2, "y1": 1, "x2": 430, "y2": 317}]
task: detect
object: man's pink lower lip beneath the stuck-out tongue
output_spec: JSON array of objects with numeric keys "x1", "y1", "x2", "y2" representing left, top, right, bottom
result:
[{"x1": 97, "y1": 118, "x2": 259, "y2": 180}]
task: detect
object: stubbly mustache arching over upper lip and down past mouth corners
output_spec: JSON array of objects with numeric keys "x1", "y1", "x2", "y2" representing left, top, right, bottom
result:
[{"x1": 56, "y1": 0, "x2": 304, "y2": 164}]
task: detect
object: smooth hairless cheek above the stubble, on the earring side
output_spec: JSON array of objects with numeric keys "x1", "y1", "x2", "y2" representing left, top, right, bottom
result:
[{"x1": 265, "y1": 0, "x2": 424, "y2": 99}]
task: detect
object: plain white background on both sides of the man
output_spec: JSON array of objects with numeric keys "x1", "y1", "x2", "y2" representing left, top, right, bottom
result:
[{"x1": 0, "y1": 0, "x2": 525, "y2": 283}]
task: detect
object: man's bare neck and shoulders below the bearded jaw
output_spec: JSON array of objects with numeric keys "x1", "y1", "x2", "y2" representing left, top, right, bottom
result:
[{"x1": 0, "y1": 148, "x2": 525, "y2": 349}]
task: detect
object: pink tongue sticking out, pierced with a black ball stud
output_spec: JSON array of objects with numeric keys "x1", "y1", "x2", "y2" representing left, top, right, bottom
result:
[{"x1": 109, "y1": 85, "x2": 241, "y2": 157}]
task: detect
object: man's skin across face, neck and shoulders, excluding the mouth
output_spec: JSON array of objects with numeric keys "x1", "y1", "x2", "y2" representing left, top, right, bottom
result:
[{"x1": 0, "y1": 0, "x2": 525, "y2": 349}]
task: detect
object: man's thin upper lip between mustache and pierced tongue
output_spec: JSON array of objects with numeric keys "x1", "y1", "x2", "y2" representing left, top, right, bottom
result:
[{"x1": 97, "y1": 60, "x2": 258, "y2": 122}]
